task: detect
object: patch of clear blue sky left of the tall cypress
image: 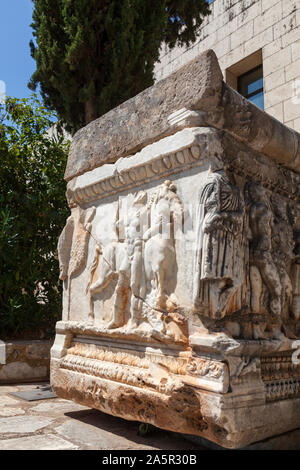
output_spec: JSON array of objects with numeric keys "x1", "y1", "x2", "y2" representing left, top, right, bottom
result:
[{"x1": 0, "y1": 0, "x2": 35, "y2": 98}]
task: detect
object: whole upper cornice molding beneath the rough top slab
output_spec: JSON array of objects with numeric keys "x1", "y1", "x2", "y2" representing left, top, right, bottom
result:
[{"x1": 67, "y1": 126, "x2": 300, "y2": 207}]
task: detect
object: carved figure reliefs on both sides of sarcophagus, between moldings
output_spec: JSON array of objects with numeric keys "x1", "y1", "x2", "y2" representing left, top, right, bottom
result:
[{"x1": 58, "y1": 126, "x2": 299, "y2": 342}]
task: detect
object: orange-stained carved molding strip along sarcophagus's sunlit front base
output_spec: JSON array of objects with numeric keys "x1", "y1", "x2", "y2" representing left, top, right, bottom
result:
[{"x1": 60, "y1": 341, "x2": 229, "y2": 394}]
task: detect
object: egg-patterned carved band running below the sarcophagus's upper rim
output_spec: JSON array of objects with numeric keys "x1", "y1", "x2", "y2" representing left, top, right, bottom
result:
[{"x1": 67, "y1": 140, "x2": 300, "y2": 206}]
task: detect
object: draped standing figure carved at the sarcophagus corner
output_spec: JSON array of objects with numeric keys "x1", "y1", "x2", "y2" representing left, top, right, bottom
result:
[{"x1": 193, "y1": 171, "x2": 244, "y2": 319}]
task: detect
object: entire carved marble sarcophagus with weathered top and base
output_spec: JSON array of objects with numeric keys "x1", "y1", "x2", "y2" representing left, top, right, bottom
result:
[{"x1": 51, "y1": 50, "x2": 300, "y2": 448}]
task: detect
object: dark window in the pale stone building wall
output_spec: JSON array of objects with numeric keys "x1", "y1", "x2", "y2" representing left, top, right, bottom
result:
[{"x1": 238, "y1": 65, "x2": 264, "y2": 109}]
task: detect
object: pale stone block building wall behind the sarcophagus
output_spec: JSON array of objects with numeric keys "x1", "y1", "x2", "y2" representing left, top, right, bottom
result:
[{"x1": 155, "y1": 0, "x2": 300, "y2": 132}]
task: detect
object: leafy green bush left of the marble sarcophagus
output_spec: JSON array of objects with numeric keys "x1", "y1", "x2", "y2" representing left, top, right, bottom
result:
[{"x1": 0, "y1": 97, "x2": 68, "y2": 339}]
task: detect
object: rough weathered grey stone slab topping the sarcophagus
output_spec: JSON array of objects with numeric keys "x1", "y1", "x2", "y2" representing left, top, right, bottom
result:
[{"x1": 65, "y1": 50, "x2": 300, "y2": 181}]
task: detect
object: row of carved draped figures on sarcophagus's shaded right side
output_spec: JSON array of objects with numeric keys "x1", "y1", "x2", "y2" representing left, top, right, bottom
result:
[{"x1": 193, "y1": 170, "x2": 299, "y2": 339}]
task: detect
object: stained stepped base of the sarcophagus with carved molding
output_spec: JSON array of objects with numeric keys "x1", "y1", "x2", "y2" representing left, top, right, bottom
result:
[{"x1": 51, "y1": 322, "x2": 300, "y2": 449}]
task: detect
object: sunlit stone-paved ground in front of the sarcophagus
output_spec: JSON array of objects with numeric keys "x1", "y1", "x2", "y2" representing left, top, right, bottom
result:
[{"x1": 0, "y1": 384, "x2": 203, "y2": 450}]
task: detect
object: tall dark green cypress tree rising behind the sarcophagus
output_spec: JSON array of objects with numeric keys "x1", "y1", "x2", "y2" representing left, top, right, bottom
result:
[{"x1": 29, "y1": 0, "x2": 209, "y2": 131}]
